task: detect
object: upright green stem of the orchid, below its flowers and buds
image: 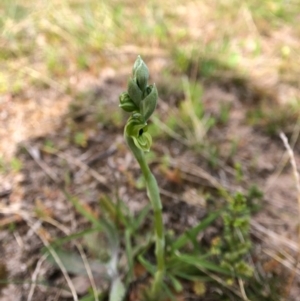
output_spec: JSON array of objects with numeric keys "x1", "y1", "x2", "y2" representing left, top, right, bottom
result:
[{"x1": 125, "y1": 134, "x2": 165, "y2": 297}]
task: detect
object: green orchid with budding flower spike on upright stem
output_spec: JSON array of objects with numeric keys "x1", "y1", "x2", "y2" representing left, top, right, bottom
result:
[{"x1": 119, "y1": 56, "x2": 165, "y2": 298}]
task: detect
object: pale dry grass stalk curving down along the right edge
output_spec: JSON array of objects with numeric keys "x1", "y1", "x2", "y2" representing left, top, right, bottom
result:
[{"x1": 280, "y1": 132, "x2": 300, "y2": 296}]
